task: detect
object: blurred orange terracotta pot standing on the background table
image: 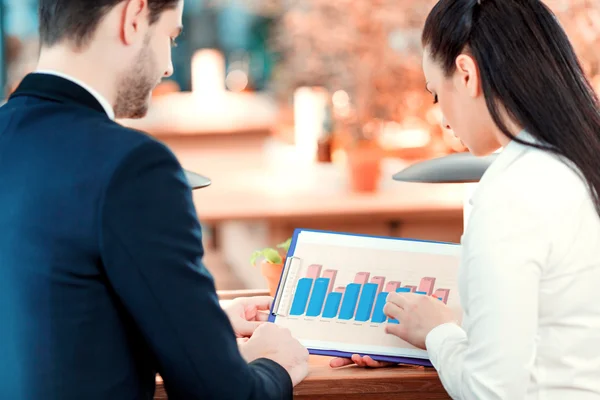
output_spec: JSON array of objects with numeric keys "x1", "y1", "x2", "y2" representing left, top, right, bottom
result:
[{"x1": 347, "y1": 142, "x2": 381, "y2": 192}]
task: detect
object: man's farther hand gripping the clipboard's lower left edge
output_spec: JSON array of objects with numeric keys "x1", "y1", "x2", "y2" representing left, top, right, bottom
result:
[{"x1": 223, "y1": 296, "x2": 273, "y2": 338}]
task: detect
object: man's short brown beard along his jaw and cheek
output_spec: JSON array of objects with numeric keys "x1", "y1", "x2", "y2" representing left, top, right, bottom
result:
[{"x1": 114, "y1": 36, "x2": 158, "y2": 118}]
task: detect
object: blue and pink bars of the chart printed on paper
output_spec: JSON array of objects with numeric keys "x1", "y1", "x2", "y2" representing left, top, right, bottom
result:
[{"x1": 289, "y1": 264, "x2": 450, "y2": 324}]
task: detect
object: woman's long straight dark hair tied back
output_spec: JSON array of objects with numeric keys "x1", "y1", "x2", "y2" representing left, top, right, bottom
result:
[{"x1": 422, "y1": 0, "x2": 600, "y2": 214}]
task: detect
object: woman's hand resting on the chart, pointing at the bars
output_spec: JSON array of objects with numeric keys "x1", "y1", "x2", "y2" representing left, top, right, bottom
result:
[{"x1": 383, "y1": 293, "x2": 457, "y2": 349}]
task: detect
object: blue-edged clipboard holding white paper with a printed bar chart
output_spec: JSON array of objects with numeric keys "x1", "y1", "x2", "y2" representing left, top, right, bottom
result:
[{"x1": 269, "y1": 229, "x2": 462, "y2": 367}]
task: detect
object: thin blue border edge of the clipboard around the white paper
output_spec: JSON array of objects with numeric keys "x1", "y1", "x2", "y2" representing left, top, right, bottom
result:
[{"x1": 268, "y1": 228, "x2": 460, "y2": 367}]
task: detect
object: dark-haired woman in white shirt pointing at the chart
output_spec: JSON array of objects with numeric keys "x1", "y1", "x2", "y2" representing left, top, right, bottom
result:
[{"x1": 331, "y1": 0, "x2": 600, "y2": 400}]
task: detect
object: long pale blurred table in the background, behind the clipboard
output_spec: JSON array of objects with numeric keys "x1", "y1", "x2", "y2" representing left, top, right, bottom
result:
[{"x1": 180, "y1": 144, "x2": 465, "y2": 228}]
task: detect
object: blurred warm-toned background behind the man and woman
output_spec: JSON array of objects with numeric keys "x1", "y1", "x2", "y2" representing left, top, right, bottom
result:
[{"x1": 0, "y1": 0, "x2": 600, "y2": 289}]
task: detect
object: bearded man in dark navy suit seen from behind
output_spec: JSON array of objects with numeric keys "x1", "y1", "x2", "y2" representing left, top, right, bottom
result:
[{"x1": 0, "y1": 0, "x2": 308, "y2": 400}]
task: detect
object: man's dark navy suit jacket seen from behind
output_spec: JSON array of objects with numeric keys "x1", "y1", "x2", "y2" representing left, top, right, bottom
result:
[{"x1": 0, "y1": 74, "x2": 292, "y2": 400}]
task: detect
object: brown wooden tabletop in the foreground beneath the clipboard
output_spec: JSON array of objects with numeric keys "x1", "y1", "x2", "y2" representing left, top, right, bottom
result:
[{"x1": 154, "y1": 356, "x2": 450, "y2": 400}]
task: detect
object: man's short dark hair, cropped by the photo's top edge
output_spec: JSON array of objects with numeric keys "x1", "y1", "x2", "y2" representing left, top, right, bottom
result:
[{"x1": 38, "y1": 0, "x2": 179, "y2": 47}]
